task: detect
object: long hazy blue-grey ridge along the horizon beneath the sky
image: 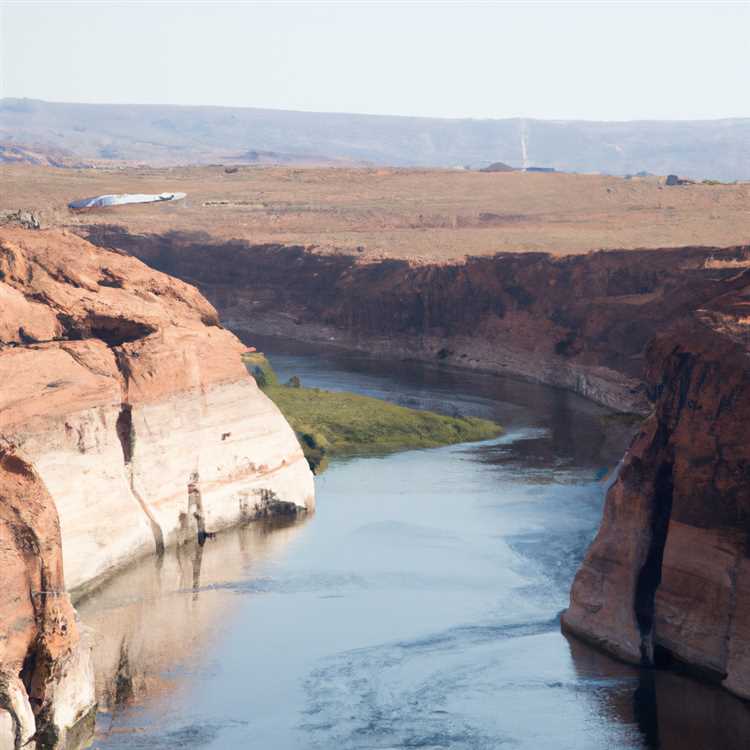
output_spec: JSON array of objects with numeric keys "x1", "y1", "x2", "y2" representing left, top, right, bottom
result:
[{"x1": 0, "y1": 99, "x2": 750, "y2": 180}]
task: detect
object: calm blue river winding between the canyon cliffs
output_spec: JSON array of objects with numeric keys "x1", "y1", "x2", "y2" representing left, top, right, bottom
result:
[{"x1": 79, "y1": 340, "x2": 750, "y2": 750}]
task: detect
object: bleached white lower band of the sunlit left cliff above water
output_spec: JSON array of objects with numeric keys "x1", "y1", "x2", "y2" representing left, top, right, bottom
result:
[{"x1": 16, "y1": 379, "x2": 314, "y2": 593}]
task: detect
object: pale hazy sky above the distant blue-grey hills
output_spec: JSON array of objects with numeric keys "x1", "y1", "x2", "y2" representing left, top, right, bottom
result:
[{"x1": 0, "y1": 0, "x2": 750, "y2": 119}]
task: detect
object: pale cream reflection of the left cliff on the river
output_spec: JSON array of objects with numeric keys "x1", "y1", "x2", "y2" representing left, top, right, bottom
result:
[{"x1": 76, "y1": 518, "x2": 305, "y2": 733}]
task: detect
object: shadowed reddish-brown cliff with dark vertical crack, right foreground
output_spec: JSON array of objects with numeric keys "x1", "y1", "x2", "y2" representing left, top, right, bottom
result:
[{"x1": 563, "y1": 271, "x2": 750, "y2": 698}]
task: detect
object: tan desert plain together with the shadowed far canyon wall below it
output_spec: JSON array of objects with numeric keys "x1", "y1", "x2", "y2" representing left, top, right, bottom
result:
[{"x1": 5, "y1": 165, "x2": 750, "y2": 413}]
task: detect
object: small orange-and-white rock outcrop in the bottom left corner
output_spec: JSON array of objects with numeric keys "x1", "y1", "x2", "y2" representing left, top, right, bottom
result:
[{"x1": 0, "y1": 450, "x2": 94, "y2": 748}]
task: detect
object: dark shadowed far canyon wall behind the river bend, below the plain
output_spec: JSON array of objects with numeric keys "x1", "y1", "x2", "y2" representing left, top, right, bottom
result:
[{"x1": 82, "y1": 225, "x2": 750, "y2": 413}]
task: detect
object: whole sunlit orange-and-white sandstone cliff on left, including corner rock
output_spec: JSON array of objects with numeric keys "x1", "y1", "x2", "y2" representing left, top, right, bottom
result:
[{"x1": 0, "y1": 230, "x2": 314, "y2": 746}]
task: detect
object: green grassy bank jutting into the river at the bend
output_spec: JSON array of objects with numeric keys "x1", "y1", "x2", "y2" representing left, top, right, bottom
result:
[{"x1": 243, "y1": 353, "x2": 502, "y2": 473}]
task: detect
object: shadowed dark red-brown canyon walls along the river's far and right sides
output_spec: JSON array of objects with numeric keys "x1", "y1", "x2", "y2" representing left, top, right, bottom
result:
[{"x1": 70, "y1": 220, "x2": 750, "y2": 698}]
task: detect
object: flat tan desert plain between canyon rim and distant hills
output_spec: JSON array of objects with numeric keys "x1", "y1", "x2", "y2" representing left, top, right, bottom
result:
[{"x1": 0, "y1": 165, "x2": 750, "y2": 262}]
